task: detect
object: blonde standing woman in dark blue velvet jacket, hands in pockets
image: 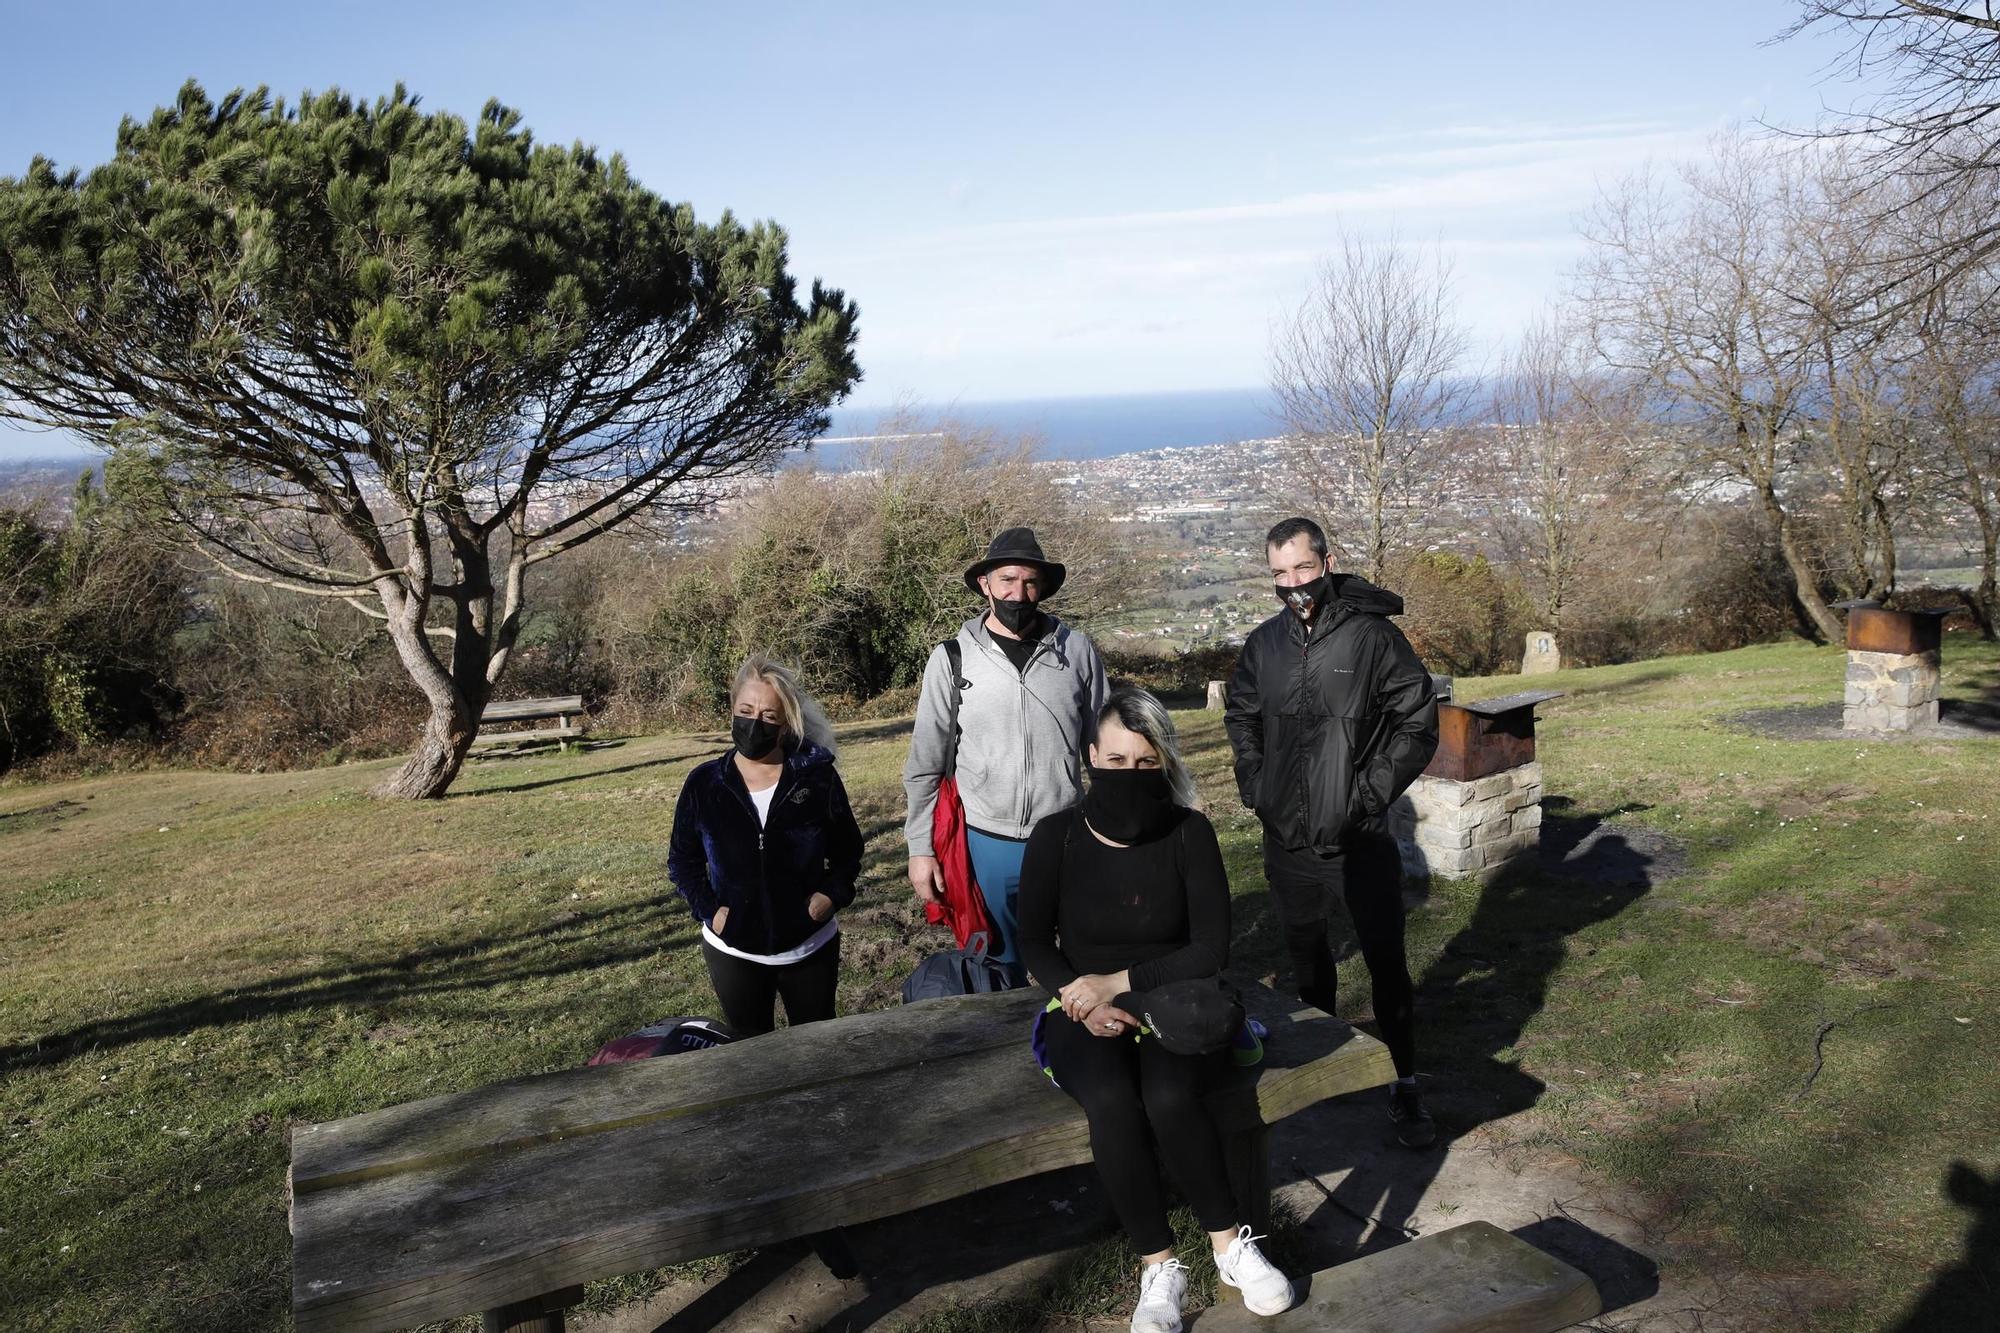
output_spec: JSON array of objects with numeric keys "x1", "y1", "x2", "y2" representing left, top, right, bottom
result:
[{"x1": 666, "y1": 656, "x2": 862, "y2": 1037}]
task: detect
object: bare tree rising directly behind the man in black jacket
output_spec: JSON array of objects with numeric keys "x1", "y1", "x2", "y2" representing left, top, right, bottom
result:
[{"x1": 1270, "y1": 234, "x2": 1474, "y2": 578}]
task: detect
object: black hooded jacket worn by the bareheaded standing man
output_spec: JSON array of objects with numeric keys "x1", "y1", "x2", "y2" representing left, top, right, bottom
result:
[{"x1": 1224, "y1": 574, "x2": 1438, "y2": 853}]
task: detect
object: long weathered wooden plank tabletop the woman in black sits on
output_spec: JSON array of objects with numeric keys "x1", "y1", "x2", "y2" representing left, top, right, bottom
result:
[{"x1": 290, "y1": 976, "x2": 1394, "y2": 1333}]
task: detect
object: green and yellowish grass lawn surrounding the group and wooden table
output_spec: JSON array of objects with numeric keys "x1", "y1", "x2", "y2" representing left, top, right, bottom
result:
[{"x1": 0, "y1": 640, "x2": 2000, "y2": 1331}]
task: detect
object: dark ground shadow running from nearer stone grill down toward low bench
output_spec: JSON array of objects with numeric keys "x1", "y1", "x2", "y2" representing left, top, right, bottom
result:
[{"x1": 1296, "y1": 799, "x2": 1656, "y2": 1249}]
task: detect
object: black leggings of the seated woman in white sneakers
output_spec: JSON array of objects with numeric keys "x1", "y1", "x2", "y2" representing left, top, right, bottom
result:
[{"x1": 1042, "y1": 1009, "x2": 1240, "y2": 1255}]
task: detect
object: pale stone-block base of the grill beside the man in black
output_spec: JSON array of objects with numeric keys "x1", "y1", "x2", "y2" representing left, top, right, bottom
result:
[{"x1": 1388, "y1": 761, "x2": 1542, "y2": 879}]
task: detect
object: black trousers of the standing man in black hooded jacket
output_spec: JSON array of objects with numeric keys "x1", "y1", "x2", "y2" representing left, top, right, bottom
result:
[{"x1": 1264, "y1": 831, "x2": 1416, "y2": 1079}]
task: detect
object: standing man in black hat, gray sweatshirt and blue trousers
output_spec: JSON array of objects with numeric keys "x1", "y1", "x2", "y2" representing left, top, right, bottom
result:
[{"x1": 902, "y1": 528, "x2": 1108, "y2": 967}]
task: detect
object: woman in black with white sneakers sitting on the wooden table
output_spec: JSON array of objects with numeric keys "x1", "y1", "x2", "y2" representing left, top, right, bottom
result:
[{"x1": 1020, "y1": 689, "x2": 1292, "y2": 1333}]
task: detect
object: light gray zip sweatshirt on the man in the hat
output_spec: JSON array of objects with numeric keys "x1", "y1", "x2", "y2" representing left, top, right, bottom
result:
[{"x1": 902, "y1": 612, "x2": 1110, "y2": 857}]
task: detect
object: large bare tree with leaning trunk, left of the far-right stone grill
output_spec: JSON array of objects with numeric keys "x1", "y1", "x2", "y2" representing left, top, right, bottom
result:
[{"x1": 1584, "y1": 136, "x2": 1844, "y2": 642}]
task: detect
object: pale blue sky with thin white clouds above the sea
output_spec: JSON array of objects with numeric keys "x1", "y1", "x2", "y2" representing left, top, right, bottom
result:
[{"x1": 0, "y1": 0, "x2": 1850, "y2": 456}]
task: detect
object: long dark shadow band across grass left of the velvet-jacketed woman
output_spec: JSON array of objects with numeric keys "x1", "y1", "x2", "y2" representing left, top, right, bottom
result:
[{"x1": 0, "y1": 899, "x2": 688, "y2": 1073}]
